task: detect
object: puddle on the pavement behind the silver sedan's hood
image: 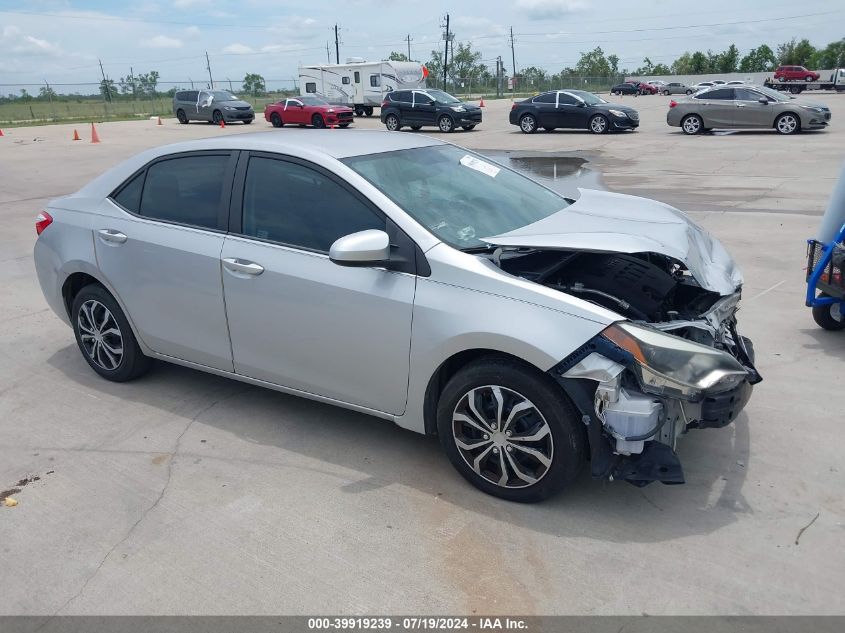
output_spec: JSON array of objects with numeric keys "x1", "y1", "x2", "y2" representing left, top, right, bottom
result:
[{"x1": 479, "y1": 150, "x2": 605, "y2": 198}]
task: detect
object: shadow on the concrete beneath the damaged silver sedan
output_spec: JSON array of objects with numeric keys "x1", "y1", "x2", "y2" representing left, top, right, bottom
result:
[{"x1": 48, "y1": 345, "x2": 751, "y2": 543}]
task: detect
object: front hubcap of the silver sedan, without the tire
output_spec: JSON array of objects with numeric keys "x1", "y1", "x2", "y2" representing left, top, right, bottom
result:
[{"x1": 452, "y1": 385, "x2": 554, "y2": 488}]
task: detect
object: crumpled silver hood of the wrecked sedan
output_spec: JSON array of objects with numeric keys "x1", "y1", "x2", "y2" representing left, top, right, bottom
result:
[{"x1": 482, "y1": 189, "x2": 742, "y2": 295}]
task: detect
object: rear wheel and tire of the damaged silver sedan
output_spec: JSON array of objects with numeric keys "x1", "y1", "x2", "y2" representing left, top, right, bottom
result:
[{"x1": 70, "y1": 284, "x2": 152, "y2": 382}]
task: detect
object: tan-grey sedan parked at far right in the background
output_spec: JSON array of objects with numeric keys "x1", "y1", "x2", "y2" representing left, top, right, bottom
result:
[{"x1": 666, "y1": 86, "x2": 830, "y2": 134}]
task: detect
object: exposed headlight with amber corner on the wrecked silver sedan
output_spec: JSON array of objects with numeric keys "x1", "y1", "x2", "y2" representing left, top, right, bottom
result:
[{"x1": 602, "y1": 322, "x2": 748, "y2": 401}]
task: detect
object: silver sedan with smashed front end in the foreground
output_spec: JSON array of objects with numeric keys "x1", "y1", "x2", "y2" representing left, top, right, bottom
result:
[{"x1": 35, "y1": 130, "x2": 760, "y2": 501}]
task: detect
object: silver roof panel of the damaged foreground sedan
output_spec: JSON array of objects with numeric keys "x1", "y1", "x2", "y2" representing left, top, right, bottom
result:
[{"x1": 138, "y1": 130, "x2": 446, "y2": 158}]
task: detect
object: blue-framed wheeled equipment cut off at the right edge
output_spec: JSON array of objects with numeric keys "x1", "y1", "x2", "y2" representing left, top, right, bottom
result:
[{"x1": 805, "y1": 165, "x2": 845, "y2": 330}]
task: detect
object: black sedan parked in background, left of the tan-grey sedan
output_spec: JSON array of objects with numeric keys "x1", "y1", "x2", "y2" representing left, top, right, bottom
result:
[{"x1": 510, "y1": 90, "x2": 640, "y2": 134}]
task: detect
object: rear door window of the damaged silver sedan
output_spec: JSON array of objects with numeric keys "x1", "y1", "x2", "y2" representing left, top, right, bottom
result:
[{"x1": 139, "y1": 154, "x2": 229, "y2": 229}]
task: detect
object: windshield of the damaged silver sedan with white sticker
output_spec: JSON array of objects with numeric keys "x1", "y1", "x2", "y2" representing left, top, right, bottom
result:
[{"x1": 343, "y1": 145, "x2": 569, "y2": 249}]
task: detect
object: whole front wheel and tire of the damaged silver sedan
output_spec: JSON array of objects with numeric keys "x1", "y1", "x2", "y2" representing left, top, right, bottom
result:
[{"x1": 437, "y1": 357, "x2": 586, "y2": 502}]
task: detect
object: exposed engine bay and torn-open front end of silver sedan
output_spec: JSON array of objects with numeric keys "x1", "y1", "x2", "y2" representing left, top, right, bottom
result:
[{"x1": 491, "y1": 247, "x2": 760, "y2": 485}]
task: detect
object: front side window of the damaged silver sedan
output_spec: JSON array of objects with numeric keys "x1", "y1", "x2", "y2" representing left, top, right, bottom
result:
[{"x1": 243, "y1": 156, "x2": 385, "y2": 253}]
